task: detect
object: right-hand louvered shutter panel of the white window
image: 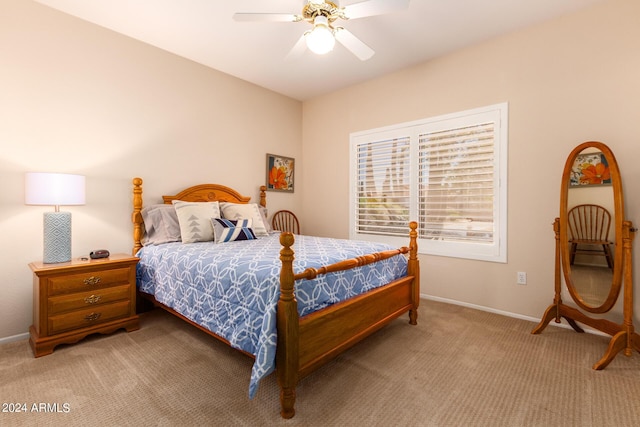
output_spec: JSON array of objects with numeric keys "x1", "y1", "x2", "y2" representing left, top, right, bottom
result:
[{"x1": 418, "y1": 122, "x2": 495, "y2": 243}]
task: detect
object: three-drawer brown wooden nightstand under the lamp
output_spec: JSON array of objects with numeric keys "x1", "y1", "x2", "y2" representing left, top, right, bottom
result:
[{"x1": 29, "y1": 254, "x2": 140, "y2": 357}]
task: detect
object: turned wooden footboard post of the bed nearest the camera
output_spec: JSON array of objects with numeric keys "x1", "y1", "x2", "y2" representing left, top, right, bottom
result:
[{"x1": 276, "y1": 232, "x2": 300, "y2": 418}]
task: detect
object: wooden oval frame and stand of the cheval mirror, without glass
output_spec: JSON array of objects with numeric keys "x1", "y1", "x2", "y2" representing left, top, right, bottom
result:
[{"x1": 531, "y1": 141, "x2": 640, "y2": 370}]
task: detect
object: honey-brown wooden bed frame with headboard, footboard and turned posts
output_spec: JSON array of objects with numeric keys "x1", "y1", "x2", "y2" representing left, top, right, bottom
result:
[{"x1": 132, "y1": 178, "x2": 420, "y2": 418}]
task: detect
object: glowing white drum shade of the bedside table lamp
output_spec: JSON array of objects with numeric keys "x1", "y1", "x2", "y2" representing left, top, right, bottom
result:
[{"x1": 24, "y1": 172, "x2": 85, "y2": 206}]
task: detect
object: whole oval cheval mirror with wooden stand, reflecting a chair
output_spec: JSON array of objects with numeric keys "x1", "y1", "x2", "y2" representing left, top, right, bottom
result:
[{"x1": 531, "y1": 141, "x2": 640, "y2": 370}]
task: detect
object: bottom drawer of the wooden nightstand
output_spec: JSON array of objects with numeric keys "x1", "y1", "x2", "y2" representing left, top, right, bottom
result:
[{"x1": 48, "y1": 301, "x2": 131, "y2": 334}]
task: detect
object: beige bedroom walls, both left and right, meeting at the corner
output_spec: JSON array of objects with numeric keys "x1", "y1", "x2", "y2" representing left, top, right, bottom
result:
[{"x1": 0, "y1": 0, "x2": 640, "y2": 339}]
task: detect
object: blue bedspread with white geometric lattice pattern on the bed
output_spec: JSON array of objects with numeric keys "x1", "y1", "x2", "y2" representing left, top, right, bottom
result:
[{"x1": 137, "y1": 234, "x2": 407, "y2": 397}]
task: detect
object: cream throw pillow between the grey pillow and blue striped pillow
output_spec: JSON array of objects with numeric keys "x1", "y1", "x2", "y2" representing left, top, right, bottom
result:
[{"x1": 172, "y1": 200, "x2": 220, "y2": 243}]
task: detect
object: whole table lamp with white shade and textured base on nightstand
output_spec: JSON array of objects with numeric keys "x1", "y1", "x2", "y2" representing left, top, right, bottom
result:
[{"x1": 24, "y1": 172, "x2": 85, "y2": 264}]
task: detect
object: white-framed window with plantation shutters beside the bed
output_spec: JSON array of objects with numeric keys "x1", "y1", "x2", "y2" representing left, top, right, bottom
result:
[{"x1": 350, "y1": 103, "x2": 508, "y2": 262}]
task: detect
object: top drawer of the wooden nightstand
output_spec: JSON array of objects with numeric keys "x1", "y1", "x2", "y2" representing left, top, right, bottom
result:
[{"x1": 49, "y1": 268, "x2": 131, "y2": 296}]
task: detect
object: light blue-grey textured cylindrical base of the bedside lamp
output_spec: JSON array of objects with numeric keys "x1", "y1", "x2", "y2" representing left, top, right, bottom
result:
[{"x1": 43, "y1": 212, "x2": 71, "y2": 264}]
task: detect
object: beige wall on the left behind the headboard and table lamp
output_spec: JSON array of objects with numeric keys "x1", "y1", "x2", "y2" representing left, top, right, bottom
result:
[{"x1": 0, "y1": 0, "x2": 304, "y2": 338}]
